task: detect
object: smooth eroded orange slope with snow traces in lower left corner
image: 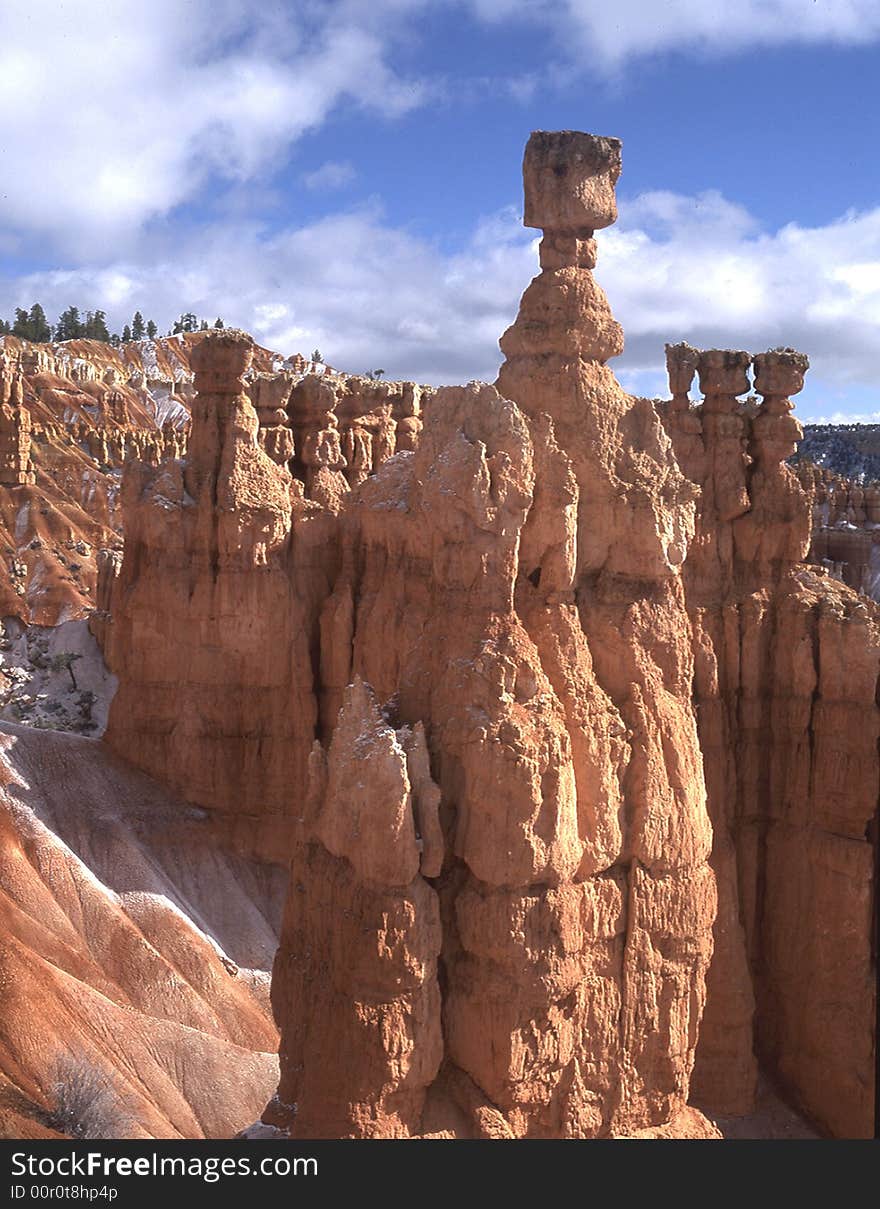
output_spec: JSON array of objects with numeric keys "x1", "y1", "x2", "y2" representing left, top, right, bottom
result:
[{"x1": 0, "y1": 723, "x2": 285, "y2": 1138}]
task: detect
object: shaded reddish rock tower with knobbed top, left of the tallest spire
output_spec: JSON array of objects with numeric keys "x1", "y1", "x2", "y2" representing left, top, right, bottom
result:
[{"x1": 102, "y1": 331, "x2": 325, "y2": 851}]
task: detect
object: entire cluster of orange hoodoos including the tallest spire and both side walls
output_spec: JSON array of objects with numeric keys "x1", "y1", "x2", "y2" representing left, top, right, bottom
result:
[{"x1": 84, "y1": 132, "x2": 880, "y2": 1138}]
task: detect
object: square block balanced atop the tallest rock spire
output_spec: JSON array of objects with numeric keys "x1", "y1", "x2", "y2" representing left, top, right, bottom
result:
[{"x1": 522, "y1": 131, "x2": 621, "y2": 231}]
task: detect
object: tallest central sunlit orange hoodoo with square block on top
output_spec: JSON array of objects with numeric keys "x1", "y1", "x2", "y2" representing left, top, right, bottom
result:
[{"x1": 245, "y1": 137, "x2": 714, "y2": 1136}]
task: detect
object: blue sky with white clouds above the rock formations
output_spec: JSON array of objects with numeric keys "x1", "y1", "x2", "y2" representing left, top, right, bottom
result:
[{"x1": 0, "y1": 0, "x2": 880, "y2": 420}]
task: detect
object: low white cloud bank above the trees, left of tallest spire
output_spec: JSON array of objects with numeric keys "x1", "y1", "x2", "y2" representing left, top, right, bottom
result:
[{"x1": 0, "y1": 208, "x2": 535, "y2": 382}]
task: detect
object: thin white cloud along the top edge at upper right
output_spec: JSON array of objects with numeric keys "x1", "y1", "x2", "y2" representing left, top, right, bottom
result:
[{"x1": 470, "y1": 0, "x2": 880, "y2": 68}]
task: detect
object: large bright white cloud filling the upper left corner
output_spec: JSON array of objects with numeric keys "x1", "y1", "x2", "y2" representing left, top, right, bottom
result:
[{"x1": 0, "y1": 0, "x2": 424, "y2": 252}]
